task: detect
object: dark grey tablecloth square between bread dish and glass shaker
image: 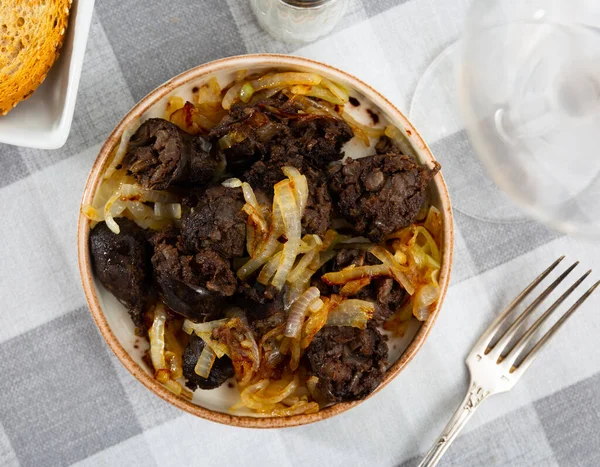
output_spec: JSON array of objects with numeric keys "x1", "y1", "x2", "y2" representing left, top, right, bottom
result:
[{"x1": 96, "y1": 0, "x2": 246, "y2": 100}]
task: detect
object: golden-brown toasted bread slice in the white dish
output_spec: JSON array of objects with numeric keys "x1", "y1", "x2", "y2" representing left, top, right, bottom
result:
[{"x1": 0, "y1": 0, "x2": 72, "y2": 115}]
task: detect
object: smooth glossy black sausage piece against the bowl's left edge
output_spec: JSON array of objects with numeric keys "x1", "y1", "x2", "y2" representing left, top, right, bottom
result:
[{"x1": 90, "y1": 218, "x2": 152, "y2": 326}]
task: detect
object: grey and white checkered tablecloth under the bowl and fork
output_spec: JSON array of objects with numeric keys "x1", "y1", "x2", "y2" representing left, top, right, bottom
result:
[{"x1": 0, "y1": 0, "x2": 600, "y2": 466}]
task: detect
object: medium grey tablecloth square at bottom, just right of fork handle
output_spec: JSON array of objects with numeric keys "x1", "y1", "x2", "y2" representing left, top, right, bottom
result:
[{"x1": 402, "y1": 405, "x2": 556, "y2": 467}]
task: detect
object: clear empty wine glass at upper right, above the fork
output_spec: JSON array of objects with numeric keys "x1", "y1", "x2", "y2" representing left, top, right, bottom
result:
[{"x1": 411, "y1": 0, "x2": 600, "y2": 237}]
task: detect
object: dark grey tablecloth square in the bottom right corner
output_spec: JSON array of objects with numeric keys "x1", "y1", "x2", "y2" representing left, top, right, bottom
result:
[{"x1": 534, "y1": 373, "x2": 600, "y2": 467}]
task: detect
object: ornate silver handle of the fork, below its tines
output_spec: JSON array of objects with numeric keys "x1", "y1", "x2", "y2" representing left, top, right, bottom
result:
[{"x1": 419, "y1": 381, "x2": 490, "y2": 467}]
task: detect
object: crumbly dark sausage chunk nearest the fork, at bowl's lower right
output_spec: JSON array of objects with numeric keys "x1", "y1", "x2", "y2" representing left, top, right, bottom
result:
[{"x1": 306, "y1": 326, "x2": 388, "y2": 402}]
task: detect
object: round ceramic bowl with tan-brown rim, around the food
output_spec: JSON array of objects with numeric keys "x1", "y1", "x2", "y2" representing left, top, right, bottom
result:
[{"x1": 78, "y1": 54, "x2": 453, "y2": 428}]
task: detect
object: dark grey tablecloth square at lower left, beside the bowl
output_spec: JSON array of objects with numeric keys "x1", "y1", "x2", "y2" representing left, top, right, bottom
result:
[{"x1": 0, "y1": 308, "x2": 141, "y2": 466}]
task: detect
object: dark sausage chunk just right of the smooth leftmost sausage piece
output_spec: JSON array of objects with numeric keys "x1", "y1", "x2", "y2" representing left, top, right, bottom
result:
[{"x1": 151, "y1": 228, "x2": 237, "y2": 321}]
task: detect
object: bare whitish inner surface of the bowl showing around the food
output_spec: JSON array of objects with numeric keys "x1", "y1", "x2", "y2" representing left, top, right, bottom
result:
[{"x1": 90, "y1": 64, "x2": 448, "y2": 416}]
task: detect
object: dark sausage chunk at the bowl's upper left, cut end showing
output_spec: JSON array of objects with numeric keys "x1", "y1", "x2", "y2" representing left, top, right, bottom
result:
[{"x1": 123, "y1": 118, "x2": 225, "y2": 190}]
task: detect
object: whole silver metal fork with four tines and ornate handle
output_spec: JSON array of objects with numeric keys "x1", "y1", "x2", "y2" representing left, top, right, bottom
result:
[{"x1": 419, "y1": 256, "x2": 600, "y2": 467}]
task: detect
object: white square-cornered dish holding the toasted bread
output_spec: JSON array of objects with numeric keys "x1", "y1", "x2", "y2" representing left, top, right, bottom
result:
[{"x1": 0, "y1": 0, "x2": 94, "y2": 149}]
